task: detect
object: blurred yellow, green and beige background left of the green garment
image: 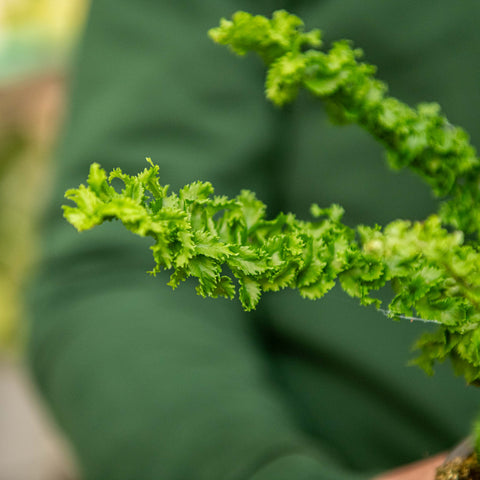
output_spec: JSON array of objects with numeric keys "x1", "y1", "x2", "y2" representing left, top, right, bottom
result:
[{"x1": 0, "y1": 0, "x2": 89, "y2": 480}]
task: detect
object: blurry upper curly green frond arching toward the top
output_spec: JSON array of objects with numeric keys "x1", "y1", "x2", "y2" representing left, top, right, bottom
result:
[{"x1": 210, "y1": 11, "x2": 480, "y2": 236}]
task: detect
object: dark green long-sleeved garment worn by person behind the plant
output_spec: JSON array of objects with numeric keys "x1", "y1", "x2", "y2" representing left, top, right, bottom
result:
[{"x1": 29, "y1": 0, "x2": 480, "y2": 480}]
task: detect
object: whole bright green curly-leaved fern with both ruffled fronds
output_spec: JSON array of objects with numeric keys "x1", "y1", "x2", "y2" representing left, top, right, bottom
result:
[{"x1": 63, "y1": 11, "x2": 480, "y2": 454}]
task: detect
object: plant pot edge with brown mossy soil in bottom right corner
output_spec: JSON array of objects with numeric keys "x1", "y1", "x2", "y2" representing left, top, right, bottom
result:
[{"x1": 435, "y1": 437, "x2": 480, "y2": 480}]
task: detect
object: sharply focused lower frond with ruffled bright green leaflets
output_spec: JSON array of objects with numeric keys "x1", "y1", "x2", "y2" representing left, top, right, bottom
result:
[{"x1": 63, "y1": 159, "x2": 480, "y2": 382}]
